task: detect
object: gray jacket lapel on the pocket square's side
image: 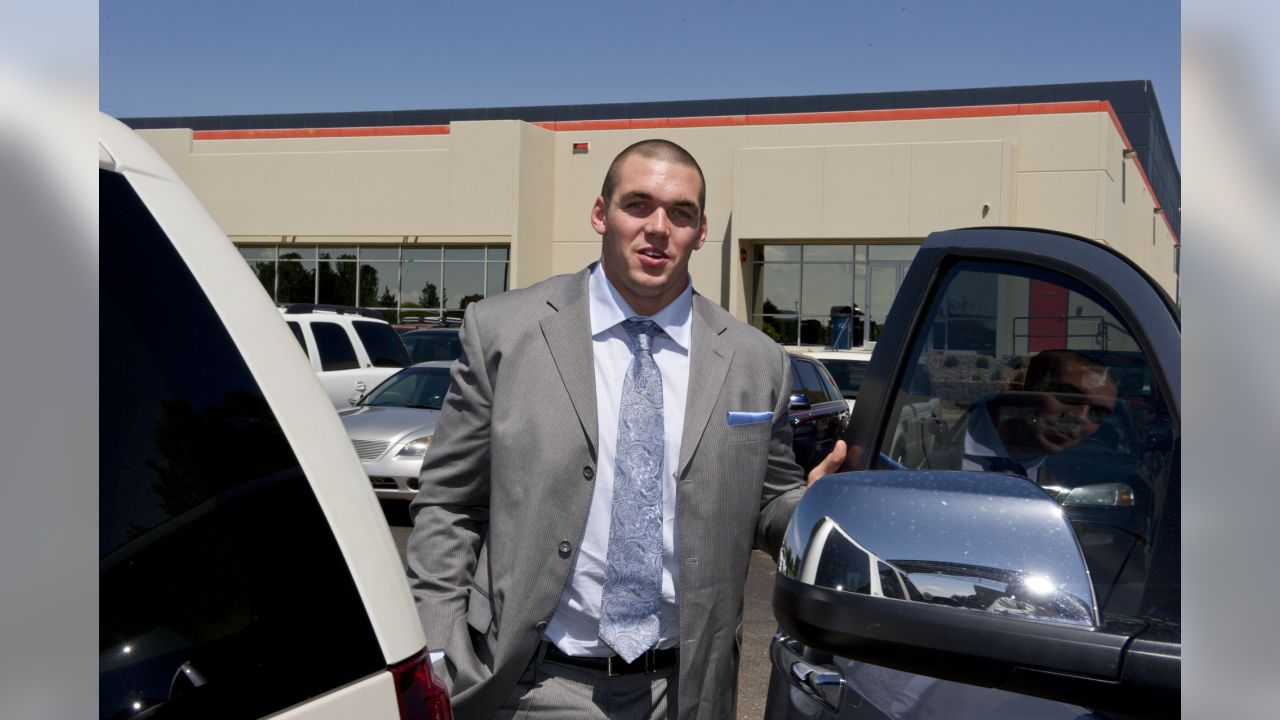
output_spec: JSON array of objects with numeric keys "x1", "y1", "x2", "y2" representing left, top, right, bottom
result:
[{"x1": 677, "y1": 295, "x2": 733, "y2": 477}]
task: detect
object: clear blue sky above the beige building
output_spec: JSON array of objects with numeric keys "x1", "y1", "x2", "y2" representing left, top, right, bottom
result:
[{"x1": 99, "y1": 0, "x2": 1181, "y2": 163}]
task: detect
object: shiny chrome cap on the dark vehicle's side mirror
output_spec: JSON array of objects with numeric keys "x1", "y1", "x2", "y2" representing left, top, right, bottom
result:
[{"x1": 778, "y1": 470, "x2": 1098, "y2": 626}]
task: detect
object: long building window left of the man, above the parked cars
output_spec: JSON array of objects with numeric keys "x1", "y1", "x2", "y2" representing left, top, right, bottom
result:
[{"x1": 239, "y1": 245, "x2": 509, "y2": 322}]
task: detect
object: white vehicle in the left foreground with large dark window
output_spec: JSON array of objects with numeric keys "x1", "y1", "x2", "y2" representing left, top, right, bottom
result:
[{"x1": 97, "y1": 115, "x2": 452, "y2": 719}]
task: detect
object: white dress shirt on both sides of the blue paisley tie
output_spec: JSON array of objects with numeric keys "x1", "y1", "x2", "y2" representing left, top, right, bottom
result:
[{"x1": 545, "y1": 263, "x2": 694, "y2": 657}]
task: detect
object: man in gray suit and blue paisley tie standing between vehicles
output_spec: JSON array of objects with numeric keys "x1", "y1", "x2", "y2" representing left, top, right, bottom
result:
[{"x1": 407, "y1": 140, "x2": 845, "y2": 719}]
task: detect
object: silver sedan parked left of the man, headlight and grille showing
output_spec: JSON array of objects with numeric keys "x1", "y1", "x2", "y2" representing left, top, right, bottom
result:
[{"x1": 338, "y1": 360, "x2": 453, "y2": 500}]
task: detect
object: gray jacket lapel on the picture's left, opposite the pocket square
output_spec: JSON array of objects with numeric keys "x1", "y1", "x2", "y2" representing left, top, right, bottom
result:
[{"x1": 541, "y1": 269, "x2": 599, "y2": 457}]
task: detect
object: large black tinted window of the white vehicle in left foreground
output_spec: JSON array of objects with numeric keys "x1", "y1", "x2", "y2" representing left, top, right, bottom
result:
[{"x1": 99, "y1": 172, "x2": 385, "y2": 717}]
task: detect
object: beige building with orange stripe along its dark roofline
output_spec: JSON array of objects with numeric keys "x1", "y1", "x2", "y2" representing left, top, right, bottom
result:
[{"x1": 128, "y1": 83, "x2": 1179, "y2": 345}]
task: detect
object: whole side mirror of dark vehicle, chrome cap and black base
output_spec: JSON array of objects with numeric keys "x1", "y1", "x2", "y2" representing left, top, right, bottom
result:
[{"x1": 773, "y1": 470, "x2": 1180, "y2": 716}]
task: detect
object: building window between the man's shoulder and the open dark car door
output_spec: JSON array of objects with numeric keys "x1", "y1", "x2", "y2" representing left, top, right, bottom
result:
[{"x1": 751, "y1": 245, "x2": 919, "y2": 347}]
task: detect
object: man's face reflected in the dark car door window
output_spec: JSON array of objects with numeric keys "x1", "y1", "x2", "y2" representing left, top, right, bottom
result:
[{"x1": 1032, "y1": 360, "x2": 1116, "y2": 454}]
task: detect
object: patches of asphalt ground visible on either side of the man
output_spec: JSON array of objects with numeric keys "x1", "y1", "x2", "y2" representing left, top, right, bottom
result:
[{"x1": 383, "y1": 501, "x2": 777, "y2": 719}]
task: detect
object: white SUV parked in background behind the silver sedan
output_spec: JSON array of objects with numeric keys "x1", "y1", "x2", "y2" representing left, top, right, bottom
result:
[{"x1": 280, "y1": 302, "x2": 410, "y2": 410}]
